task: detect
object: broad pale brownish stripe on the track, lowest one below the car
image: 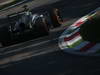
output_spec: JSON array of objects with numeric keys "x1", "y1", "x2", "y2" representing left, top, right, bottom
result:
[{"x1": 0, "y1": 47, "x2": 57, "y2": 66}]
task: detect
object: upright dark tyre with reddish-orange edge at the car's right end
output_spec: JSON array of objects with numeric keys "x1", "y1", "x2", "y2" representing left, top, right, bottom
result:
[{"x1": 48, "y1": 8, "x2": 63, "y2": 28}]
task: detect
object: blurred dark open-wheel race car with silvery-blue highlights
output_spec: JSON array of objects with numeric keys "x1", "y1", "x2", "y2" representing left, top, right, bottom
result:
[{"x1": 0, "y1": 8, "x2": 61, "y2": 47}]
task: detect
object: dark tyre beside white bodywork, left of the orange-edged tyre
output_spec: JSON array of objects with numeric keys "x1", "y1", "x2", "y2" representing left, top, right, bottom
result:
[{"x1": 35, "y1": 18, "x2": 49, "y2": 35}]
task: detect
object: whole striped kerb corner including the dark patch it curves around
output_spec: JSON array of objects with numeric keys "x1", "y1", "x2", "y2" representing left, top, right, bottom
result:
[{"x1": 58, "y1": 8, "x2": 100, "y2": 55}]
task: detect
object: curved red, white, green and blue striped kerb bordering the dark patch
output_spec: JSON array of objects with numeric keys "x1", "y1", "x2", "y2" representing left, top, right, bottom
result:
[{"x1": 58, "y1": 8, "x2": 100, "y2": 55}]
